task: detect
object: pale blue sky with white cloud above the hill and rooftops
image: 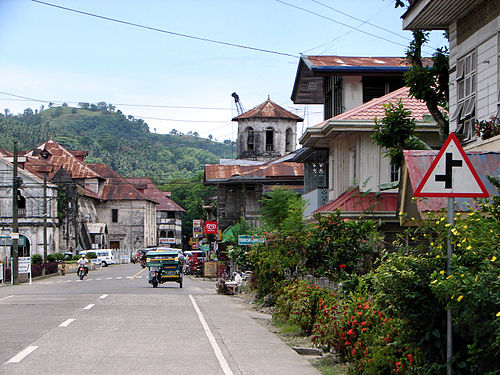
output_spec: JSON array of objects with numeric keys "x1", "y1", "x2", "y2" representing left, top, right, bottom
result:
[{"x1": 0, "y1": 0, "x2": 445, "y2": 141}]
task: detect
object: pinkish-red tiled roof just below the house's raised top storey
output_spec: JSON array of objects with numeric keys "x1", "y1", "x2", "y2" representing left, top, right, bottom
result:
[{"x1": 315, "y1": 87, "x2": 429, "y2": 127}]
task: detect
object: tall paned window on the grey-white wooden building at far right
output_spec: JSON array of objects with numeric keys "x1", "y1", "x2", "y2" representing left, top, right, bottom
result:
[{"x1": 451, "y1": 51, "x2": 477, "y2": 141}]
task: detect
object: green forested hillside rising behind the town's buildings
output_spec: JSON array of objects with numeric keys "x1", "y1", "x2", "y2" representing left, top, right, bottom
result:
[{"x1": 0, "y1": 102, "x2": 234, "y2": 183}]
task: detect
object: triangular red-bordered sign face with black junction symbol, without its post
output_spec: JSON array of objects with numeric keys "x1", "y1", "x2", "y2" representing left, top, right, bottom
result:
[{"x1": 414, "y1": 133, "x2": 489, "y2": 198}]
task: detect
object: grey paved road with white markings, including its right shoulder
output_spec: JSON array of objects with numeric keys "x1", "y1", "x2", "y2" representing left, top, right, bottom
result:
[{"x1": 0, "y1": 264, "x2": 318, "y2": 375}]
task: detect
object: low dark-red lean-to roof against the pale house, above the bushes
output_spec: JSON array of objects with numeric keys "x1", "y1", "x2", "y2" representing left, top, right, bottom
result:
[{"x1": 314, "y1": 188, "x2": 398, "y2": 214}]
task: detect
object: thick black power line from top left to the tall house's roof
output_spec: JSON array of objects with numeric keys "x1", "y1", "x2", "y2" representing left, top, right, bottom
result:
[{"x1": 31, "y1": 0, "x2": 299, "y2": 58}]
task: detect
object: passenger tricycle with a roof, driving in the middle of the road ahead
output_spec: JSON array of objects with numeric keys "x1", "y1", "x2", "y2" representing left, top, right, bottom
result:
[{"x1": 146, "y1": 248, "x2": 184, "y2": 288}]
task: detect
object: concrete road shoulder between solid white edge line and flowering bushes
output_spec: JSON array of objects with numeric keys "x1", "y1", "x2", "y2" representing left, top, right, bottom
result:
[{"x1": 195, "y1": 294, "x2": 320, "y2": 375}]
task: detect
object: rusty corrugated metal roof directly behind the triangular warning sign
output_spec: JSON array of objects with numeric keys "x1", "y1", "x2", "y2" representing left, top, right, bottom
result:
[{"x1": 404, "y1": 150, "x2": 500, "y2": 212}]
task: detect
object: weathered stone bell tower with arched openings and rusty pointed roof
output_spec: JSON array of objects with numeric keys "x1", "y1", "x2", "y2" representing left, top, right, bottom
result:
[{"x1": 233, "y1": 98, "x2": 304, "y2": 161}]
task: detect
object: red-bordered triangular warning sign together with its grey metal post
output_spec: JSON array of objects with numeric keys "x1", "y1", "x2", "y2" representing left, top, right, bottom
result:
[{"x1": 414, "y1": 133, "x2": 489, "y2": 375}]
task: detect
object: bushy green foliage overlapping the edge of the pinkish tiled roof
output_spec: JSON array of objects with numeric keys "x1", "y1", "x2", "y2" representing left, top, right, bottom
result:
[{"x1": 370, "y1": 99, "x2": 425, "y2": 168}]
